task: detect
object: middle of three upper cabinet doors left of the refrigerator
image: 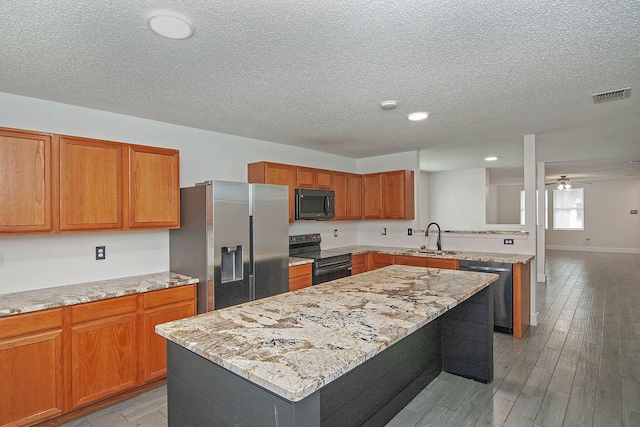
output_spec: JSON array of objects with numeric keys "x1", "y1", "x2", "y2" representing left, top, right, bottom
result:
[{"x1": 60, "y1": 136, "x2": 123, "y2": 231}]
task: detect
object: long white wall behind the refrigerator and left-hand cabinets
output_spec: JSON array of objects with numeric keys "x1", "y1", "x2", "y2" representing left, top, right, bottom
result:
[{"x1": 0, "y1": 93, "x2": 357, "y2": 294}]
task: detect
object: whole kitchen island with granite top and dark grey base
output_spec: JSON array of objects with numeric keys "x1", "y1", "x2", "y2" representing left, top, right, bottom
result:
[{"x1": 156, "y1": 265, "x2": 497, "y2": 427}]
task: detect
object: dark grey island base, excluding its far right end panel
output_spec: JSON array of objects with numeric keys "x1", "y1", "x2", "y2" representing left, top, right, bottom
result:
[{"x1": 167, "y1": 319, "x2": 442, "y2": 427}]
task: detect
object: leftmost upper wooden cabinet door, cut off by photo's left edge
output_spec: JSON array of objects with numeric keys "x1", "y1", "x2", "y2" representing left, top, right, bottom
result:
[{"x1": 0, "y1": 130, "x2": 53, "y2": 234}]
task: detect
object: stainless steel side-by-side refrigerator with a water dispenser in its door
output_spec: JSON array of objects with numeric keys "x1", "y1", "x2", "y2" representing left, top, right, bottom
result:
[{"x1": 169, "y1": 181, "x2": 289, "y2": 313}]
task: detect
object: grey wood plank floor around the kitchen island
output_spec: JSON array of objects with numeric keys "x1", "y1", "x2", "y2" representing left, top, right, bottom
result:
[{"x1": 57, "y1": 251, "x2": 640, "y2": 427}]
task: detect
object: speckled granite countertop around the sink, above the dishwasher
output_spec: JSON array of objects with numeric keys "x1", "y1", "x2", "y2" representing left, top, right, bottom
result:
[{"x1": 331, "y1": 245, "x2": 534, "y2": 264}]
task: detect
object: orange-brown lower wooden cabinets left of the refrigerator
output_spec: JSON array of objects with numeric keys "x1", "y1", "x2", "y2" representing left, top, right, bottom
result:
[{"x1": 0, "y1": 284, "x2": 196, "y2": 427}]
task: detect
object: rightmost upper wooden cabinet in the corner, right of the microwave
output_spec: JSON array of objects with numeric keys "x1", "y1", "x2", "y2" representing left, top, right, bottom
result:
[{"x1": 362, "y1": 170, "x2": 415, "y2": 219}]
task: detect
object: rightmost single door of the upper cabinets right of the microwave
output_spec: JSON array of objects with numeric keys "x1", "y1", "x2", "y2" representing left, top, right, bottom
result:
[{"x1": 382, "y1": 170, "x2": 415, "y2": 219}]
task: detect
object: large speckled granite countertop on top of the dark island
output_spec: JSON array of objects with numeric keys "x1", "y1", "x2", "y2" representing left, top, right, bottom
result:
[{"x1": 156, "y1": 265, "x2": 498, "y2": 401}]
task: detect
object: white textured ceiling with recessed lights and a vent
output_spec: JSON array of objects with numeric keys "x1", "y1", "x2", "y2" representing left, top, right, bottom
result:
[{"x1": 0, "y1": 0, "x2": 640, "y2": 177}]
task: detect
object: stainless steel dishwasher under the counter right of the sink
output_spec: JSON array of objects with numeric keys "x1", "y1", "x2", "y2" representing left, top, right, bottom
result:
[{"x1": 459, "y1": 260, "x2": 513, "y2": 334}]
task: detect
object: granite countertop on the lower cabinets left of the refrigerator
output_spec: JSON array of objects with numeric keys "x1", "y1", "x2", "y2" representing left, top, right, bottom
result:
[{"x1": 0, "y1": 271, "x2": 198, "y2": 317}]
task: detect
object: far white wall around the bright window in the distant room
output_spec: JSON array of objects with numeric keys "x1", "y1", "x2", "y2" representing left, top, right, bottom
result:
[{"x1": 545, "y1": 179, "x2": 640, "y2": 253}]
